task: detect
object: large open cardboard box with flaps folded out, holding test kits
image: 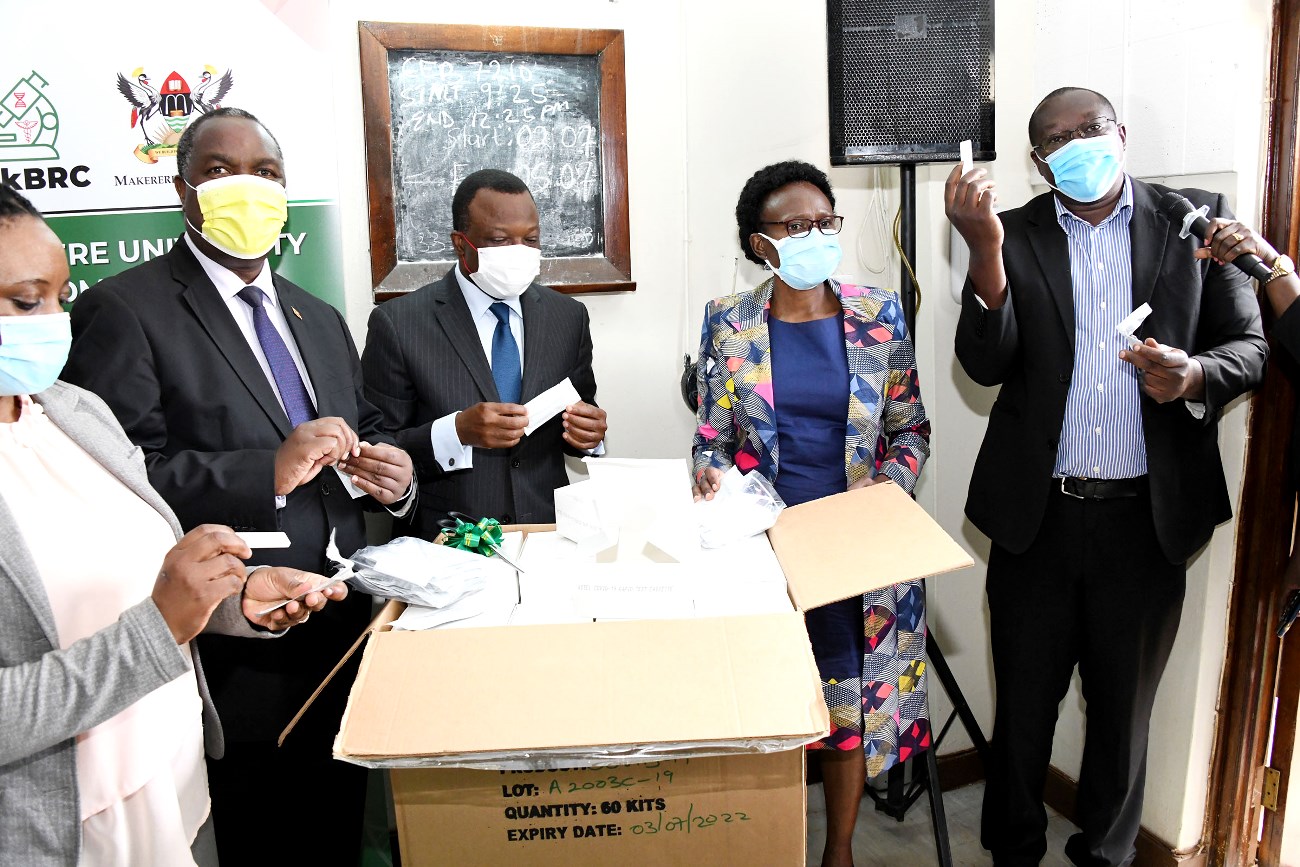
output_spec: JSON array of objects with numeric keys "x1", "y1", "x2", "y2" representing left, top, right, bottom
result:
[{"x1": 286, "y1": 484, "x2": 971, "y2": 866}]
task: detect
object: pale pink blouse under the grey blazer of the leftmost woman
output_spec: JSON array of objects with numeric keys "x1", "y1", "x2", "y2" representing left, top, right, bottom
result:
[{"x1": 0, "y1": 398, "x2": 208, "y2": 867}]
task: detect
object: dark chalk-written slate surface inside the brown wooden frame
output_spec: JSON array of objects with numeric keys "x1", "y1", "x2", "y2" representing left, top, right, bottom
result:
[{"x1": 389, "y1": 49, "x2": 605, "y2": 261}]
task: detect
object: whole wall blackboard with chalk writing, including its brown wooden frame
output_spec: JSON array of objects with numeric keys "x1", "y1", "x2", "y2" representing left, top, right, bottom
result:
[{"x1": 359, "y1": 22, "x2": 634, "y2": 299}]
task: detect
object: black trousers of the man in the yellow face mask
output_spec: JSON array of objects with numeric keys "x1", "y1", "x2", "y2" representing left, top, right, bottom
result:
[{"x1": 208, "y1": 733, "x2": 365, "y2": 867}]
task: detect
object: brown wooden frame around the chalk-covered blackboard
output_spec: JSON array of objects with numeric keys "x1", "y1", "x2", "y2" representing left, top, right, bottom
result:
[{"x1": 358, "y1": 21, "x2": 637, "y2": 300}]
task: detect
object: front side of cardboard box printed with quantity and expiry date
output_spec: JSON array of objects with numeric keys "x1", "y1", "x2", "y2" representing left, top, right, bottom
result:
[{"x1": 391, "y1": 749, "x2": 805, "y2": 867}]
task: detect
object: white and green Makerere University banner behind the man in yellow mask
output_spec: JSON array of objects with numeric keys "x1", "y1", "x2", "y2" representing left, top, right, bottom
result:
[{"x1": 0, "y1": 0, "x2": 343, "y2": 309}]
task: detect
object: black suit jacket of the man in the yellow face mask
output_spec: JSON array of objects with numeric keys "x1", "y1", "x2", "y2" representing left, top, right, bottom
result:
[{"x1": 64, "y1": 239, "x2": 391, "y2": 744}]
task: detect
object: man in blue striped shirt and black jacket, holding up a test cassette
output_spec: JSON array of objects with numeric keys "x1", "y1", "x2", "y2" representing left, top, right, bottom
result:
[{"x1": 945, "y1": 87, "x2": 1268, "y2": 866}]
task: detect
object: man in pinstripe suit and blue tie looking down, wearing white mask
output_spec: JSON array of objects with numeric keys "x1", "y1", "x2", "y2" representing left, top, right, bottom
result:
[{"x1": 361, "y1": 169, "x2": 606, "y2": 538}]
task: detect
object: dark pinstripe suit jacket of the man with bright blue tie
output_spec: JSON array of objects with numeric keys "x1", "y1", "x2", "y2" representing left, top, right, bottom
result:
[{"x1": 361, "y1": 270, "x2": 595, "y2": 538}]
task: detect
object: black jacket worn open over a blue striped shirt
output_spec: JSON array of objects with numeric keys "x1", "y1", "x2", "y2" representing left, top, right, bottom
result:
[{"x1": 957, "y1": 179, "x2": 1268, "y2": 563}]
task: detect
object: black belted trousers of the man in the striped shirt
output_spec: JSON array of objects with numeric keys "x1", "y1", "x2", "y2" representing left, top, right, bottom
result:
[{"x1": 982, "y1": 482, "x2": 1187, "y2": 867}]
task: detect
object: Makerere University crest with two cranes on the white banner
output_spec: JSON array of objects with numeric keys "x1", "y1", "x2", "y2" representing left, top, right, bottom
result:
[{"x1": 117, "y1": 66, "x2": 235, "y2": 165}]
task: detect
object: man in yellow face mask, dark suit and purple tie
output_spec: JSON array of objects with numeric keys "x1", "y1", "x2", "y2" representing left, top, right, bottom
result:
[{"x1": 64, "y1": 108, "x2": 413, "y2": 864}]
